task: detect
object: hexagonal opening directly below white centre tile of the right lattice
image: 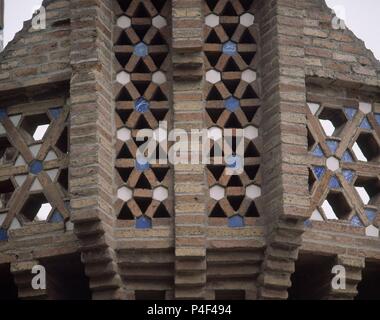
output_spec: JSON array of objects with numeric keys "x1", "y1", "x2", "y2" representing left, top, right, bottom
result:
[{"x1": 322, "y1": 191, "x2": 352, "y2": 220}]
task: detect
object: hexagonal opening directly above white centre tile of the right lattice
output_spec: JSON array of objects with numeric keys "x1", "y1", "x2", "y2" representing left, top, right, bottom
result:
[{"x1": 318, "y1": 107, "x2": 347, "y2": 137}]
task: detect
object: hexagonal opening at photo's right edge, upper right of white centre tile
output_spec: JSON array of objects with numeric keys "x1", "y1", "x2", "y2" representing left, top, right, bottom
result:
[{"x1": 352, "y1": 133, "x2": 380, "y2": 162}]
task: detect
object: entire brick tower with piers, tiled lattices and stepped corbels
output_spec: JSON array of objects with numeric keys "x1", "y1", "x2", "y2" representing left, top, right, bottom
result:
[{"x1": 0, "y1": 0, "x2": 380, "y2": 300}]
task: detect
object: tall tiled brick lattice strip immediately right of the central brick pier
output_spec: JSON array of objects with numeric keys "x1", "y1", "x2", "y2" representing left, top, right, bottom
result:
[{"x1": 204, "y1": 0, "x2": 261, "y2": 227}]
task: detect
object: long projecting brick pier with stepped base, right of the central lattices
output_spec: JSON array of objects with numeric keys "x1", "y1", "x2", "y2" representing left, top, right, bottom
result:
[{"x1": 258, "y1": 0, "x2": 310, "y2": 299}]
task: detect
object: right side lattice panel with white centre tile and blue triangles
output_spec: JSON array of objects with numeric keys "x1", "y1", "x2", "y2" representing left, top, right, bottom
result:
[{"x1": 308, "y1": 96, "x2": 380, "y2": 237}]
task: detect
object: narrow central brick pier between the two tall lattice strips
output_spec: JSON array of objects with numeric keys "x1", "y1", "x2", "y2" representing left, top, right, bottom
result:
[{"x1": 173, "y1": 0, "x2": 207, "y2": 299}]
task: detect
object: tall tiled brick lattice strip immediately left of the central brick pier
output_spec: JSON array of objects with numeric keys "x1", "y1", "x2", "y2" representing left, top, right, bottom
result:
[{"x1": 114, "y1": 0, "x2": 172, "y2": 228}]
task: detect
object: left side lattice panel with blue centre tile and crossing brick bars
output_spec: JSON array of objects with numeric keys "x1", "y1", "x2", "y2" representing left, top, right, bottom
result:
[{"x1": 0, "y1": 100, "x2": 69, "y2": 240}]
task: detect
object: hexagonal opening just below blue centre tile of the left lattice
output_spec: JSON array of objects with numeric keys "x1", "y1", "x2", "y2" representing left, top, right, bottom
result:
[{"x1": 21, "y1": 193, "x2": 52, "y2": 222}]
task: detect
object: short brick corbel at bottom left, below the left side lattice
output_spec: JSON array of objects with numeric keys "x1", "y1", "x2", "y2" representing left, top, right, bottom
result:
[{"x1": 11, "y1": 260, "x2": 48, "y2": 300}]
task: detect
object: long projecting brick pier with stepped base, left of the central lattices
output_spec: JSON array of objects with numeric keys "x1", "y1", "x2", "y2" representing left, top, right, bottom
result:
[{"x1": 69, "y1": 0, "x2": 125, "y2": 299}]
